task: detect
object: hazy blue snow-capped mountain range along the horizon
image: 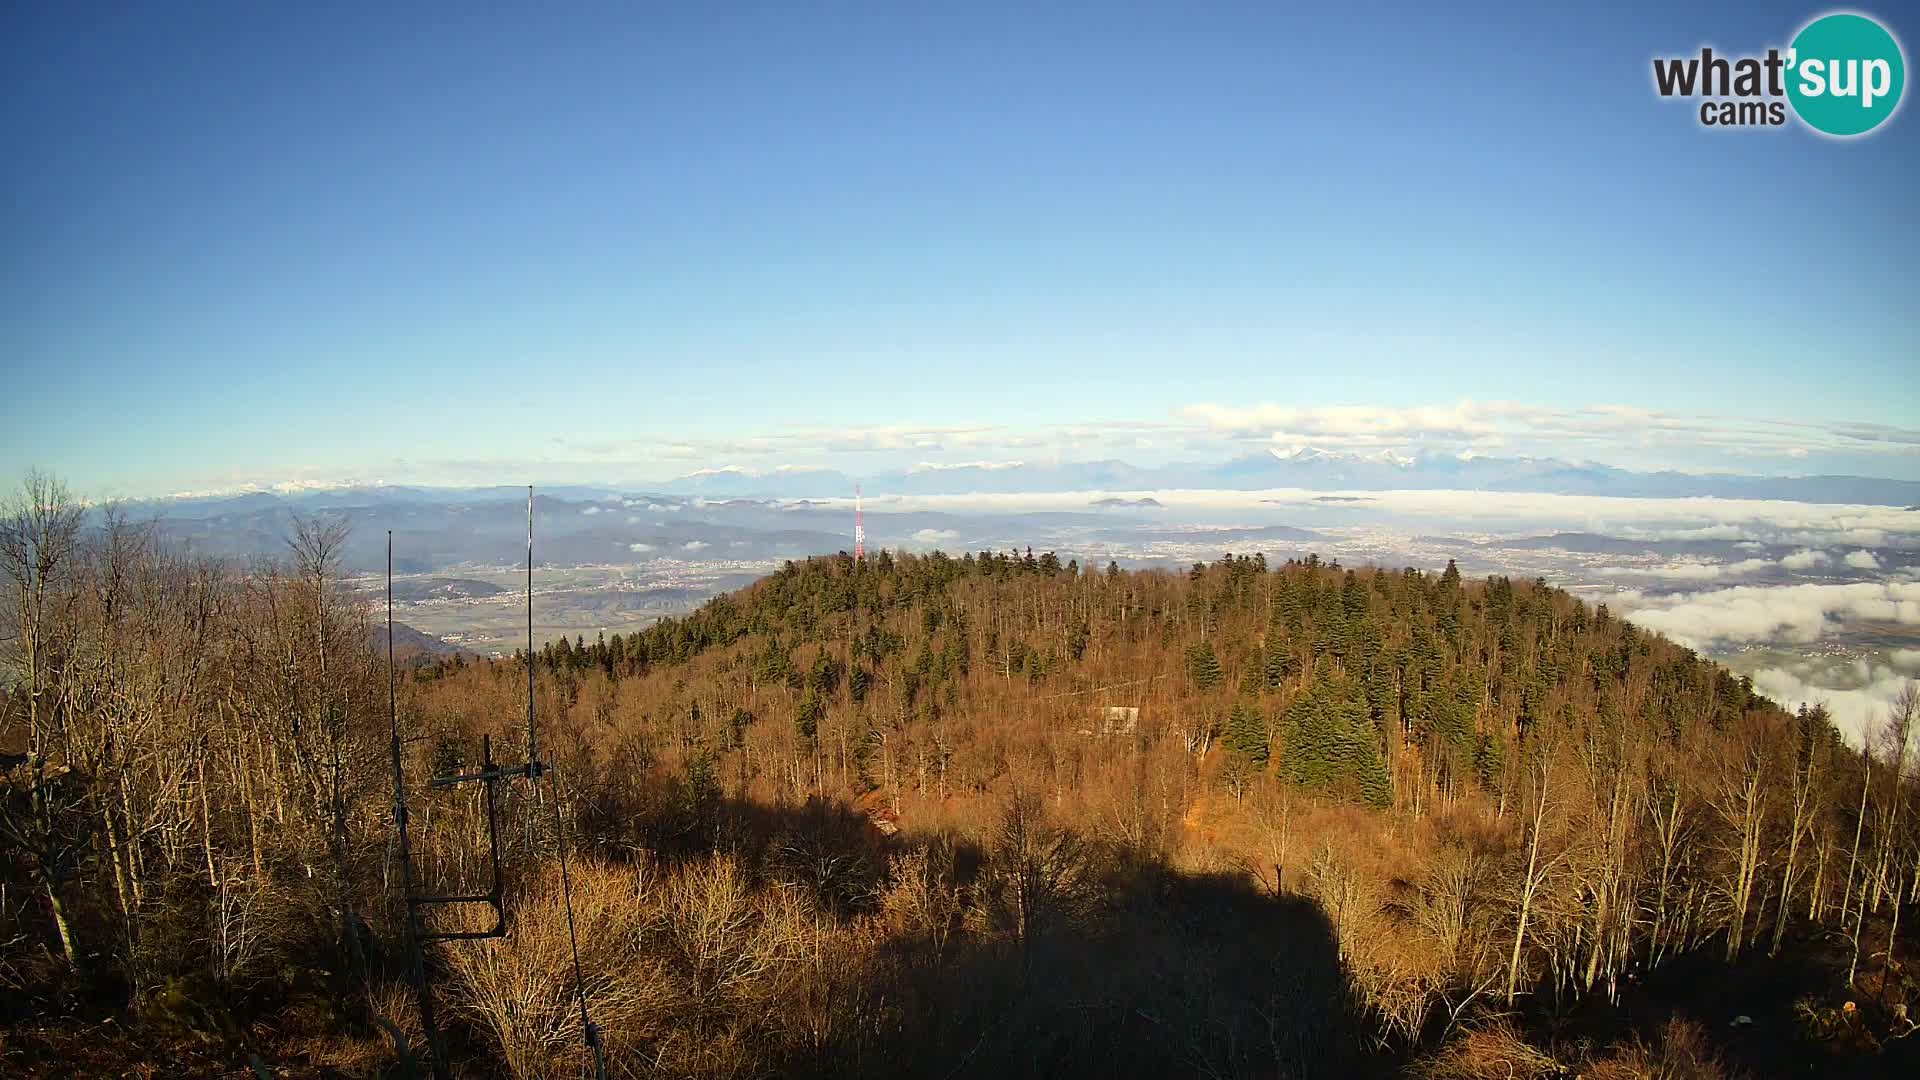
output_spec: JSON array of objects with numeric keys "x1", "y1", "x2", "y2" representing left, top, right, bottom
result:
[{"x1": 660, "y1": 446, "x2": 1920, "y2": 505}]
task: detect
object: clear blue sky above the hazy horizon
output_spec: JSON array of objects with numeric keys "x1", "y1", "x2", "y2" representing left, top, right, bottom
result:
[{"x1": 0, "y1": 4, "x2": 1920, "y2": 494}]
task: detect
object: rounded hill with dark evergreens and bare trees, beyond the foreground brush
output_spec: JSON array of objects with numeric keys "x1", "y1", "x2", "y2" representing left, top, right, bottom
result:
[{"x1": 506, "y1": 550, "x2": 1797, "y2": 807}]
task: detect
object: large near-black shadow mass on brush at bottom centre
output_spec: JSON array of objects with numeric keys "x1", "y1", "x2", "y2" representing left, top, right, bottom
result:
[{"x1": 848, "y1": 869, "x2": 1390, "y2": 1076}]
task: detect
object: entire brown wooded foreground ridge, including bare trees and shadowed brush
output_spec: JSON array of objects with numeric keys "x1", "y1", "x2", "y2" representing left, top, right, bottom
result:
[{"x1": 0, "y1": 477, "x2": 1920, "y2": 1076}]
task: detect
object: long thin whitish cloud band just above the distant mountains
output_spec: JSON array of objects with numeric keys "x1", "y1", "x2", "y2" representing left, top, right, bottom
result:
[{"x1": 153, "y1": 400, "x2": 1920, "y2": 495}]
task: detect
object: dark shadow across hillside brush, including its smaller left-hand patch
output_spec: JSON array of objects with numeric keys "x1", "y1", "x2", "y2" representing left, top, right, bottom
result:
[{"x1": 610, "y1": 801, "x2": 1400, "y2": 1078}]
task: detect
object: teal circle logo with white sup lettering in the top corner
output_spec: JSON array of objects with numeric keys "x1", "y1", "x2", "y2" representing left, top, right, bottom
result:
[{"x1": 1788, "y1": 13, "x2": 1907, "y2": 136}]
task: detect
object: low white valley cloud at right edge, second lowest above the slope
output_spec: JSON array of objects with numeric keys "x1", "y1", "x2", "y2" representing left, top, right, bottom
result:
[{"x1": 1615, "y1": 582, "x2": 1920, "y2": 648}]
